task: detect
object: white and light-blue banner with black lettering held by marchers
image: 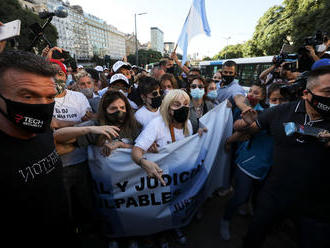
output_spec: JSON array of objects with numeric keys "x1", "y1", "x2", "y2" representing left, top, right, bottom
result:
[{"x1": 88, "y1": 102, "x2": 233, "y2": 237}]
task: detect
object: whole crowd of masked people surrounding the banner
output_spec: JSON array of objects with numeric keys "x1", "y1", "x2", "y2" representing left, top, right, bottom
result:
[{"x1": 0, "y1": 23, "x2": 330, "y2": 248}]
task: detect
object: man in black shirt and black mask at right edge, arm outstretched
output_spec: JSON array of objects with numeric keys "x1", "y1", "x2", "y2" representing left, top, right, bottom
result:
[{"x1": 238, "y1": 66, "x2": 330, "y2": 248}]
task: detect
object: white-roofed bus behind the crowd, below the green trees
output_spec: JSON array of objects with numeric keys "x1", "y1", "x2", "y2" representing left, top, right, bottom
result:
[{"x1": 199, "y1": 56, "x2": 274, "y2": 87}]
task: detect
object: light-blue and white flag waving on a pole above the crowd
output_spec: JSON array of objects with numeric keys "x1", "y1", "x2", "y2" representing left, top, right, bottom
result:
[{"x1": 177, "y1": 0, "x2": 211, "y2": 65}]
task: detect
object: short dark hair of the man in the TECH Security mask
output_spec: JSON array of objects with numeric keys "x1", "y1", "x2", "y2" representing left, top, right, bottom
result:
[{"x1": 0, "y1": 50, "x2": 56, "y2": 84}]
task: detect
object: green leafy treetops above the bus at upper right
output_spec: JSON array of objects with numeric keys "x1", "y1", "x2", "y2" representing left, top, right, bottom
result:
[{"x1": 214, "y1": 0, "x2": 330, "y2": 59}]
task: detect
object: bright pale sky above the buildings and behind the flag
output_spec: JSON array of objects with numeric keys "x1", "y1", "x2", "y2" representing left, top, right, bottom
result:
[{"x1": 69, "y1": 0, "x2": 282, "y2": 57}]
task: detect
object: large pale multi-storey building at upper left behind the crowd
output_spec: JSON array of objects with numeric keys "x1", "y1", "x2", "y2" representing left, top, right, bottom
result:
[{"x1": 19, "y1": 0, "x2": 127, "y2": 60}]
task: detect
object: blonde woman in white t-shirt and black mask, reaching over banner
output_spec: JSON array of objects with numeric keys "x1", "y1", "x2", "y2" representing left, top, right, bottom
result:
[{"x1": 132, "y1": 90, "x2": 206, "y2": 185}]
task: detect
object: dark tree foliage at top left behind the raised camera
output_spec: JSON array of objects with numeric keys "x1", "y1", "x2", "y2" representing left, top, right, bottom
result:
[{"x1": 0, "y1": 0, "x2": 58, "y2": 52}]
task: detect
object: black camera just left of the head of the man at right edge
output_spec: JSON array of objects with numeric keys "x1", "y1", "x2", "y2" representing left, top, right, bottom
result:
[{"x1": 280, "y1": 71, "x2": 310, "y2": 101}]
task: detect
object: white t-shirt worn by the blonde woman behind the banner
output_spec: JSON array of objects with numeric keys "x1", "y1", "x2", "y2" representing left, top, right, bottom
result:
[{"x1": 135, "y1": 116, "x2": 193, "y2": 151}]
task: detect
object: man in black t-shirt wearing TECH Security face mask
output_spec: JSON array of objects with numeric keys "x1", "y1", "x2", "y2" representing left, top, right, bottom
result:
[{"x1": 0, "y1": 51, "x2": 75, "y2": 247}]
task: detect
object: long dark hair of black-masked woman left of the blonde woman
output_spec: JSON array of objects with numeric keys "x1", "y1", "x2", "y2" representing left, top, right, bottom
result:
[{"x1": 97, "y1": 89, "x2": 141, "y2": 145}]
